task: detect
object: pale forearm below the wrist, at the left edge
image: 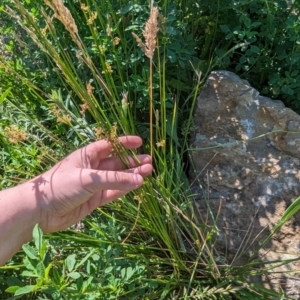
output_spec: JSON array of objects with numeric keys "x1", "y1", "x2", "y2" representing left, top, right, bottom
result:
[{"x1": 0, "y1": 183, "x2": 39, "y2": 265}]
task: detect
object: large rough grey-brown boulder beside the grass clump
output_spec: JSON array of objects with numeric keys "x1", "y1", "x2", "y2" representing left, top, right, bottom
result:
[{"x1": 190, "y1": 71, "x2": 300, "y2": 299}]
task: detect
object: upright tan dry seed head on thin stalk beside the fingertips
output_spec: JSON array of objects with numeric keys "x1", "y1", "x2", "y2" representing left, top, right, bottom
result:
[{"x1": 132, "y1": 1, "x2": 159, "y2": 156}]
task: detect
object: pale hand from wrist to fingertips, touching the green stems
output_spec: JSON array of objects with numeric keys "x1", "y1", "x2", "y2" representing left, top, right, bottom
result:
[{"x1": 28, "y1": 136, "x2": 152, "y2": 232}]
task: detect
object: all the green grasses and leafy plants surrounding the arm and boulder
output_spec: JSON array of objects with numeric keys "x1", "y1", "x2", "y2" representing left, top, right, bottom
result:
[{"x1": 0, "y1": 0, "x2": 300, "y2": 300}]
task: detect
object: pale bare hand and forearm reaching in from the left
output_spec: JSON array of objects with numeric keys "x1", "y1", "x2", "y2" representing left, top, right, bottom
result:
[{"x1": 0, "y1": 136, "x2": 152, "y2": 265}]
